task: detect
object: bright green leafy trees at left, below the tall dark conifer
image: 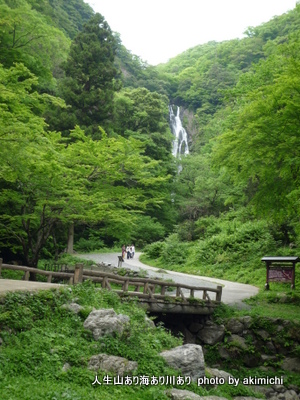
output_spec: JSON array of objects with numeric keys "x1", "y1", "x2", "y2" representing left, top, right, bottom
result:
[{"x1": 0, "y1": 65, "x2": 165, "y2": 267}]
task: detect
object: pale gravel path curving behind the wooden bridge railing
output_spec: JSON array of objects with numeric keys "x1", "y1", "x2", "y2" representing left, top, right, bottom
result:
[{"x1": 79, "y1": 253, "x2": 258, "y2": 308}]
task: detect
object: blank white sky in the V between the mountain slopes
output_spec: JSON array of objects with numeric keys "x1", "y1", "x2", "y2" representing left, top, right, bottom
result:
[{"x1": 85, "y1": 0, "x2": 296, "y2": 65}]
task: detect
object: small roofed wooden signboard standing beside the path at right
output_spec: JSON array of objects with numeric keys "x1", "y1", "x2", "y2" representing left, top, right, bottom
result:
[{"x1": 261, "y1": 257, "x2": 299, "y2": 290}]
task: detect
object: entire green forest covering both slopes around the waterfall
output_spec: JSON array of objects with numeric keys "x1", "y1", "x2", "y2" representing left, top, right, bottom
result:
[{"x1": 0, "y1": 0, "x2": 300, "y2": 277}]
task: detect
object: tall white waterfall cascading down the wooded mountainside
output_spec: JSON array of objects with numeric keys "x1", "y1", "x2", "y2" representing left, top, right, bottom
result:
[{"x1": 169, "y1": 106, "x2": 189, "y2": 158}]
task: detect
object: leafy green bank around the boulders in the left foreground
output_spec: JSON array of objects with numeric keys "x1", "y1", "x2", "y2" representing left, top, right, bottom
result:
[{"x1": 0, "y1": 282, "x2": 264, "y2": 400}]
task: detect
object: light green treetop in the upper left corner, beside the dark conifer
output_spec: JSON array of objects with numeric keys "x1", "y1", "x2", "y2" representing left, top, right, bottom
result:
[{"x1": 0, "y1": 1, "x2": 70, "y2": 93}]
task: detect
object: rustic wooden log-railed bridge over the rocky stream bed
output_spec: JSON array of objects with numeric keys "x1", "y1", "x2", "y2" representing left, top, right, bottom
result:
[{"x1": 0, "y1": 259, "x2": 222, "y2": 315}]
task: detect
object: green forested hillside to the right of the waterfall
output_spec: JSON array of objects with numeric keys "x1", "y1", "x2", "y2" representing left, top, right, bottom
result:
[{"x1": 142, "y1": 5, "x2": 300, "y2": 282}]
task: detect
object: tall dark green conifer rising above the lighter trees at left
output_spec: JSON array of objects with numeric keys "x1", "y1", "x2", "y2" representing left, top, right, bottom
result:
[{"x1": 50, "y1": 14, "x2": 118, "y2": 139}]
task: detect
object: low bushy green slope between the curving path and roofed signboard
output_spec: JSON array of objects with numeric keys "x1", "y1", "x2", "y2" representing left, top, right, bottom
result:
[{"x1": 142, "y1": 210, "x2": 300, "y2": 289}]
